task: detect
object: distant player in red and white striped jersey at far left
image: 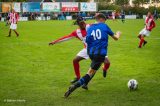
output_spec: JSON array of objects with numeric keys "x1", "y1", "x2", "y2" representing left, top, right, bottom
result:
[{"x1": 7, "y1": 9, "x2": 19, "y2": 37}]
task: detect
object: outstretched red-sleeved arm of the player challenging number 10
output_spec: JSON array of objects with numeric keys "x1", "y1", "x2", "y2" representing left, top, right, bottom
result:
[{"x1": 49, "y1": 31, "x2": 76, "y2": 45}]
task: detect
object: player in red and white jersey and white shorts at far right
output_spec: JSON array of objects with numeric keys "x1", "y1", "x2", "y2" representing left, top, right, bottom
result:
[{"x1": 138, "y1": 12, "x2": 155, "y2": 48}]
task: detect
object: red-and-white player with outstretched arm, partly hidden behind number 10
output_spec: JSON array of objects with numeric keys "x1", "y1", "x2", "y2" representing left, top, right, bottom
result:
[{"x1": 49, "y1": 17, "x2": 110, "y2": 89}]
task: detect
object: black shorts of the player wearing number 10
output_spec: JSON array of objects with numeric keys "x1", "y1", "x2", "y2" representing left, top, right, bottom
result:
[{"x1": 89, "y1": 55, "x2": 105, "y2": 70}]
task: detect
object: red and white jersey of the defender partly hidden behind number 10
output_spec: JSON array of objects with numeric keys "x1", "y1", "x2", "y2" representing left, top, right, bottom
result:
[{"x1": 53, "y1": 24, "x2": 90, "y2": 48}]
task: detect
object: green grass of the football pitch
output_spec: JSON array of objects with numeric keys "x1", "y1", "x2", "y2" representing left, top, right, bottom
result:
[{"x1": 0, "y1": 20, "x2": 160, "y2": 106}]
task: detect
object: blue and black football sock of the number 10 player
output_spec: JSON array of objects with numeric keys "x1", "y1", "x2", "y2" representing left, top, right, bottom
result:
[{"x1": 74, "y1": 74, "x2": 91, "y2": 87}]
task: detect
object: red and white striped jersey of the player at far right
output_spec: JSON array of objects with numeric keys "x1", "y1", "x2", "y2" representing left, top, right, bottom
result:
[{"x1": 145, "y1": 17, "x2": 155, "y2": 31}]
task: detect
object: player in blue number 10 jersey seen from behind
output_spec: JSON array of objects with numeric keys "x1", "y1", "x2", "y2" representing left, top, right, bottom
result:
[{"x1": 64, "y1": 13, "x2": 120, "y2": 98}]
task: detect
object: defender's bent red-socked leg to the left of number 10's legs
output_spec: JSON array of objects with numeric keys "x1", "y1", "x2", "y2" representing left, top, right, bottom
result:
[{"x1": 71, "y1": 56, "x2": 84, "y2": 83}]
